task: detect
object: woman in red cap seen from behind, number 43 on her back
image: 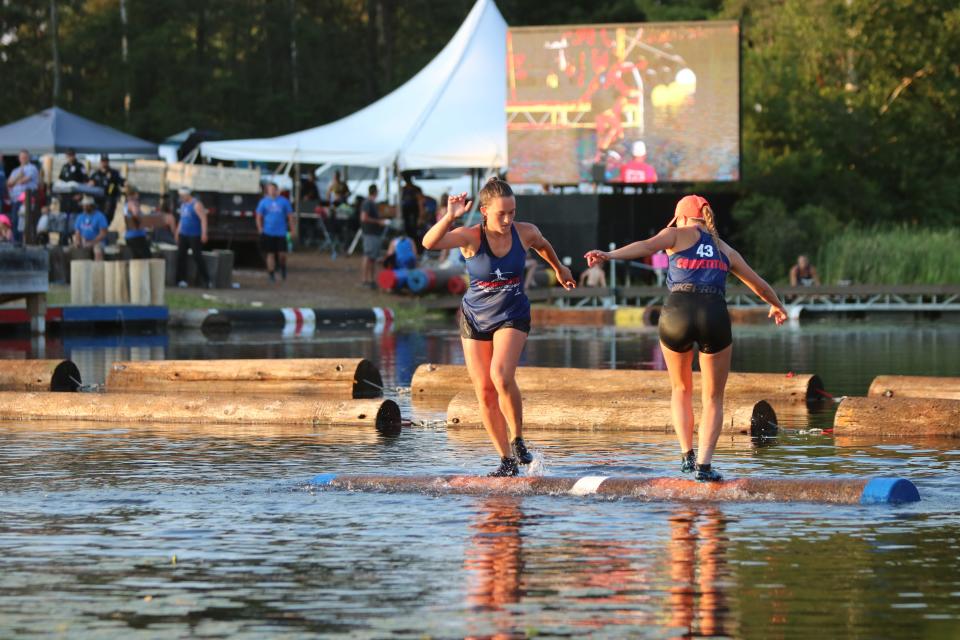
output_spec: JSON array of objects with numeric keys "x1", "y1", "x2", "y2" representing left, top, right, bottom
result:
[{"x1": 584, "y1": 196, "x2": 787, "y2": 482}]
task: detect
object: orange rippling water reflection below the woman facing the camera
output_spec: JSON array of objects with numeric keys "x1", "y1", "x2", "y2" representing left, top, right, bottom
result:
[{"x1": 464, "y1": 497, "x2": 524, "y2": 640}]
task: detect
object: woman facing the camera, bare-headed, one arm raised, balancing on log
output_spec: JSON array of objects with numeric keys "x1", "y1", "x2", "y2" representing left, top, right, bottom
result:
[{"x1": 423, "y1": 178, "x2": 576, "y2": 476}]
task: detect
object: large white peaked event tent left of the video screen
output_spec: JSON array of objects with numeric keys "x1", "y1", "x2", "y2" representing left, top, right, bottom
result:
[{"x1": 200, "y1": 0, "x2": 507, "y2": 170}]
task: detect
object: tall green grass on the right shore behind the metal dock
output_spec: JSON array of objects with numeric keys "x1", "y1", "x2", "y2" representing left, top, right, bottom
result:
[{"x1": 814, "y1": 227, "x2": 960, "y2": 284}]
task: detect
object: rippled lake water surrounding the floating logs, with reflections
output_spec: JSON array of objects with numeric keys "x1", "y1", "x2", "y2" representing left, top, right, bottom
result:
[{"x1": 0, "y1": 324, "x2": 960, "y2": 638}]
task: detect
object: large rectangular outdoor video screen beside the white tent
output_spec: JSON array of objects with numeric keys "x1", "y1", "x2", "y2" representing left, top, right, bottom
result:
[{"x1": 507, "y1": 21, "x2": 740, "y2": 184}]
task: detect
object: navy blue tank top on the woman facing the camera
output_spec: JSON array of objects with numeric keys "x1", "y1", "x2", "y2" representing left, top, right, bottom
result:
[{"x1": 461, "y1": 225, "x2": 530, "y2": 331}]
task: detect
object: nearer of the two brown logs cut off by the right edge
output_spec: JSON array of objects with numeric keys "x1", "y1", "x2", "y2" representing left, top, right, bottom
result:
[{"x1": 833, "y1": 397, "x2": 960, "y2": 438}]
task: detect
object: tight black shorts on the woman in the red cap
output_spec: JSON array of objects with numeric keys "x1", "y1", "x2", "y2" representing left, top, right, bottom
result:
[{"x1": 660, "y1": 291, "x2": 733, "y2": 353}]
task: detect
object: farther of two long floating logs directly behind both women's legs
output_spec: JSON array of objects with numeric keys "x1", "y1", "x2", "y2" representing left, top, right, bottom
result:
[{"x1": 410, "y1": 364, "x2": 824, "y2": 406}]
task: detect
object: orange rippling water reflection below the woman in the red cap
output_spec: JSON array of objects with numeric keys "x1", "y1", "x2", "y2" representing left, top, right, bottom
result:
[{"x1": 668, "y1": 507, "x2": 731, "y2": 638}]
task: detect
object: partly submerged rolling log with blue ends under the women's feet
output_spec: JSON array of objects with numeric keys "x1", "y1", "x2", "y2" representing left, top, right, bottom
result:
[{"x1": 309, "y1": 473, "x2": 920, "y2": 504}]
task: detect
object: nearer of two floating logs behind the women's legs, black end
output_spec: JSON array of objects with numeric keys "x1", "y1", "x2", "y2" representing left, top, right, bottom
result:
[{"x1": 447, "y1": 391, "x2": 777, "y2": 438}]
